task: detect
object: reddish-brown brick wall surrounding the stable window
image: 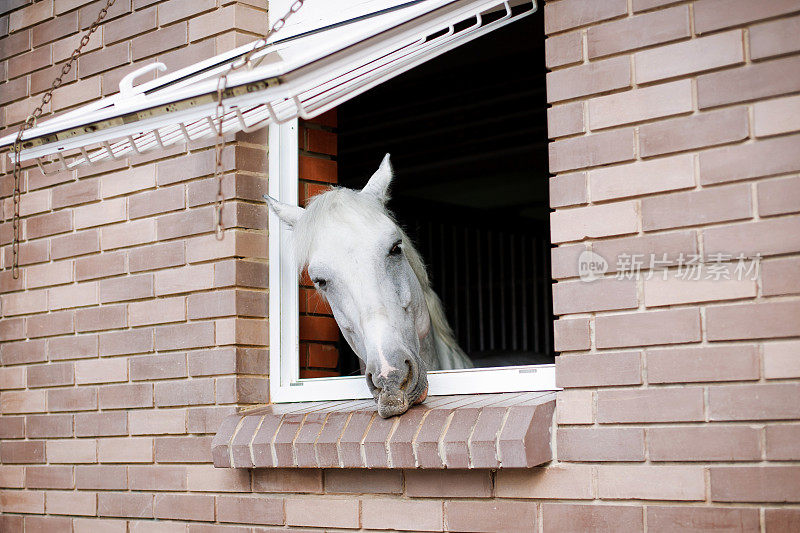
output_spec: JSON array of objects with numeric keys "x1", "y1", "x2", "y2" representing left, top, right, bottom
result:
[{"x1": 0, "y1": 0, "x2": 800, "y2": 533}]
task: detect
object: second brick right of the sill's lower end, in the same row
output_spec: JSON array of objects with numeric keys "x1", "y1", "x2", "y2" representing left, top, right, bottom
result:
[{"x1": 647, "y1": 425, "x2": 761, "y2": 461}]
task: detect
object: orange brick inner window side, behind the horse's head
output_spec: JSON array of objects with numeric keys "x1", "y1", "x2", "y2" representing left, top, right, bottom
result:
[{"x1": 298, "y1": 109, "x2": 340, "y2": 378}]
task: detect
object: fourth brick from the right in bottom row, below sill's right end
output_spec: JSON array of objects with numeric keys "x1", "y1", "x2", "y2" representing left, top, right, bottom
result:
[{"x1": 445, "y1": 500, "x2": 537, "y2": 531}]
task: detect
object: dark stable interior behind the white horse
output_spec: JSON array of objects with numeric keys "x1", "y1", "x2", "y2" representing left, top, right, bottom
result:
[{"x1": 338, "y1": 6, "x2": 555, "y2": 375}]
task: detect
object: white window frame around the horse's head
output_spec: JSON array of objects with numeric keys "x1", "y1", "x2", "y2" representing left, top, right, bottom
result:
[{"x1": 269, "y1": 120, "x2": 557, "y2": 403}]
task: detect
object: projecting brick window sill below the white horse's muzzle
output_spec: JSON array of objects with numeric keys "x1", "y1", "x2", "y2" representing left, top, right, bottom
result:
[{"x1": 212, "y1": 392, "x2": 555, "y2": 469}]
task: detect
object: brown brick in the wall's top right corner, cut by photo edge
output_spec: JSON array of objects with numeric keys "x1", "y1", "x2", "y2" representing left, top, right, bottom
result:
[{"x1": 694, "y1": 0, "x2": 798, "y2": 33}]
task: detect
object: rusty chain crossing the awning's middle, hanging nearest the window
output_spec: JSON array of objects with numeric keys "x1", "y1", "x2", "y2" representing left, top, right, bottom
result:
[{"x1": 214, "y1": 0, "x2": 305, "y2": 241}]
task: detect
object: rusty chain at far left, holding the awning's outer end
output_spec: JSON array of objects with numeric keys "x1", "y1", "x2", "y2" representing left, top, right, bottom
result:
[{"x1": 11, "y1": 0, "x2": 116, "y2": 279}]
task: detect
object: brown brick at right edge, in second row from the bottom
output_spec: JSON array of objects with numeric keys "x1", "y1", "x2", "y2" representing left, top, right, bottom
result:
[{"x1": 709, "y1": 466, "x2": 800, "y2": 502}]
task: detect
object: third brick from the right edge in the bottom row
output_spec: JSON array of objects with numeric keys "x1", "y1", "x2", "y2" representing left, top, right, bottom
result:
[{"x1": 542, "y1": 503, "x2": 644, "y2": 533}]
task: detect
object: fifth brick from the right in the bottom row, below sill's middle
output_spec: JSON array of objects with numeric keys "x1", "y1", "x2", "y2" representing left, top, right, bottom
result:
[{"x1": 361, "y1": 498, "x2": 444, "y2": 531}]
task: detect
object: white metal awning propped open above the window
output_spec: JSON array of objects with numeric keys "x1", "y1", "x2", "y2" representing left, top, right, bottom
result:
[{"x1": 0, "y1": 0, "x2": 536, "y2": 173}]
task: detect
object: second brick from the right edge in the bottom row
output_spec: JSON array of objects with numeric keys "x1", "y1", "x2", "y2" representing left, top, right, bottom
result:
[{"x1": 647, "y1": 505, "x2": 759, "y2": 533}]
